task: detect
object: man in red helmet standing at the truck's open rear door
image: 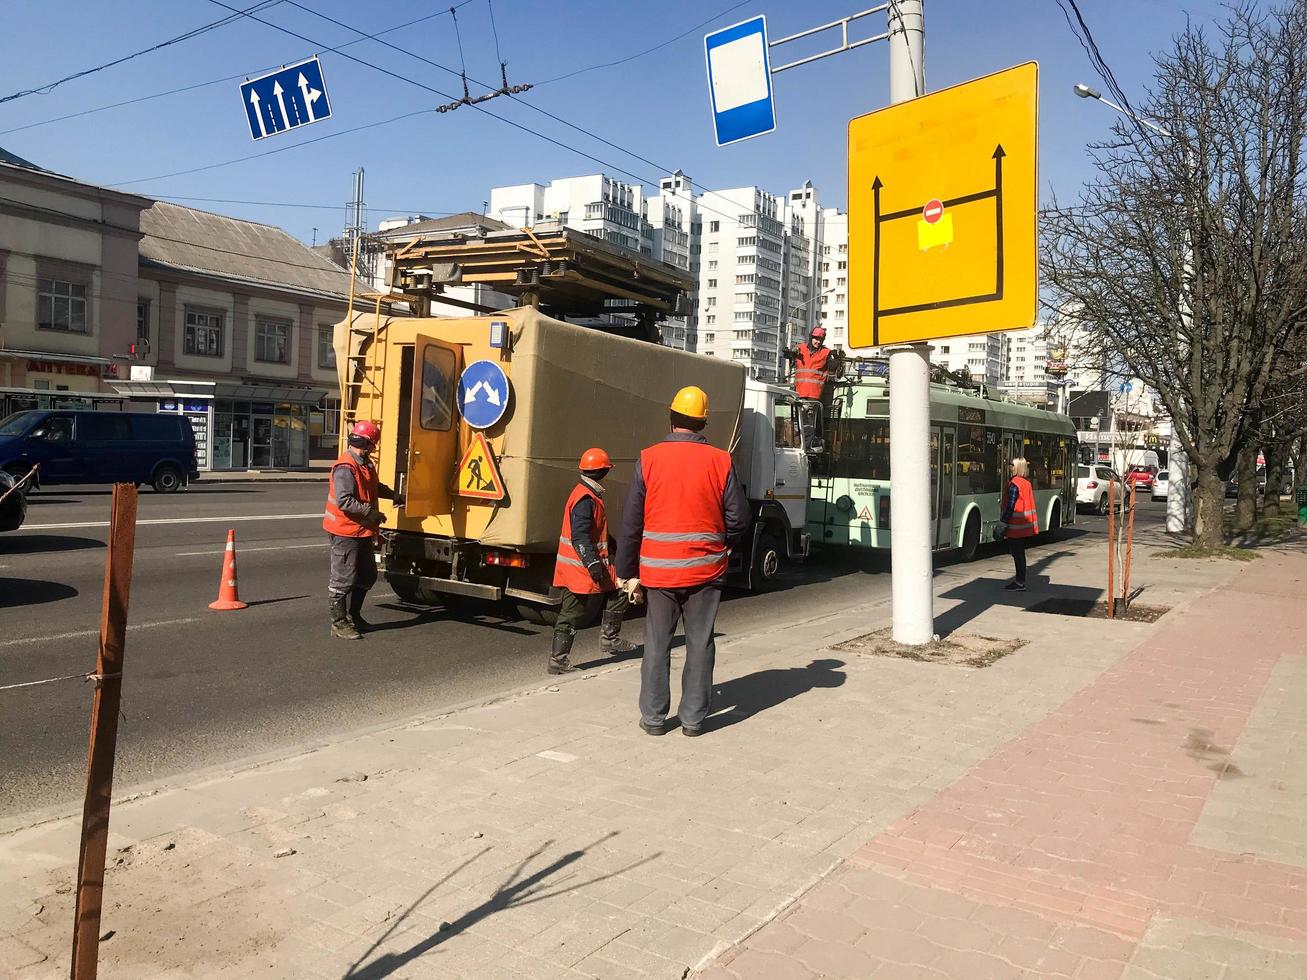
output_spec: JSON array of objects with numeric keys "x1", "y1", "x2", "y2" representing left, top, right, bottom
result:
[{"x1": 323, "y1": 421, "x2": 404, "y2": 640}]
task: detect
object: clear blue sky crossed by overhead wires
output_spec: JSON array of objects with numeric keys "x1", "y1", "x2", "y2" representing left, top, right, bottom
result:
[{"x1": 0, "y1": 0, "x2": 1221, "y2": 242}]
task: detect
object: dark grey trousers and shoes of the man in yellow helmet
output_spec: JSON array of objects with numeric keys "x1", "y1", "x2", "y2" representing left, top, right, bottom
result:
[{"x1": 640, "y1": 584, "x2": 721, "y2": 728}]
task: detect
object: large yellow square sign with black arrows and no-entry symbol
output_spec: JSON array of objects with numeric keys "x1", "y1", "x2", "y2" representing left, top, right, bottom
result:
[{"x1": 848, "y1": 61, "x2": 1039, "y2": 348}]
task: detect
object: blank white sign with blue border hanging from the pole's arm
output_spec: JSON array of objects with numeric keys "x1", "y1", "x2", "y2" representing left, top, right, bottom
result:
[{"x1": 703, "y1": 17, "x2": 776, "y2": 146}]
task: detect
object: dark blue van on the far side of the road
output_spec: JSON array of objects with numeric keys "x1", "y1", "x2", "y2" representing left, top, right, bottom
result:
[{"x1": 0, "y1": 410, "x2": 200, "y2": 494}]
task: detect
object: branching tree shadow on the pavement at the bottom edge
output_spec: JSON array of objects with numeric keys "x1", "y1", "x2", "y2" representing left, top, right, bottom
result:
[{"x1": 344, "y1": 831, "x2": 663, "y2": 980}]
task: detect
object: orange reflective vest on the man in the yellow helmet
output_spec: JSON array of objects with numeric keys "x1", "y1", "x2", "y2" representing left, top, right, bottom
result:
[{"x1": 640, "y1": 440, "x2": 731, "y2": 589}]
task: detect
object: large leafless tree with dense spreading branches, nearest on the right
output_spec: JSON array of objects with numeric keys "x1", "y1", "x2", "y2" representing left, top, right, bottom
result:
[{"x1": 1043, "y1": 0, "x2": 1307, "y2": 546}]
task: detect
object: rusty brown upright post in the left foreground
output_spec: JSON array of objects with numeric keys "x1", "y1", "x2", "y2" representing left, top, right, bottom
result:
[{"x1": 72, "y1": 483, "x2": 136, "y2": 980}]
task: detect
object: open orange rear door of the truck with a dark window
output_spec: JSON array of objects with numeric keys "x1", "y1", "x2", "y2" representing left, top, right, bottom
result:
[{"x1": 404, "y1": 335, "x2": 463, "y2": 517}]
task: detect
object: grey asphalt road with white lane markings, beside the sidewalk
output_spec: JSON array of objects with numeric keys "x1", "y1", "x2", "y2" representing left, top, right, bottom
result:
[{"x1": 0, "y1": 483, "x2": 1162, "y2": 826}]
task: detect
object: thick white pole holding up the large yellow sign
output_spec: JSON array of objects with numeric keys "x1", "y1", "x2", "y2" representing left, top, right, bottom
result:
[{"x1": 886, "y1": 0, "x2": 935, "y2": 645}]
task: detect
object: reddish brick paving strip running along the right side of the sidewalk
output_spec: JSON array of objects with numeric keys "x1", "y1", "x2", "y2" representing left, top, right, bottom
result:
[{"x1": 704, "y1": 555, "x2": 1307, "y2": 980}]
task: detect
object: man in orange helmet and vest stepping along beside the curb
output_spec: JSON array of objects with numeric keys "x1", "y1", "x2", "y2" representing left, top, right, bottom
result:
[{"x1": 549, "y1": 448, "x2": 635, "y2": 674}]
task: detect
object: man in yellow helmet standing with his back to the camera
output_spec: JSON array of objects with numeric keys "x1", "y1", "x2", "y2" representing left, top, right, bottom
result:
[{"x1": 617, "y1": 387, "x2": 749, "y2": 736}]
